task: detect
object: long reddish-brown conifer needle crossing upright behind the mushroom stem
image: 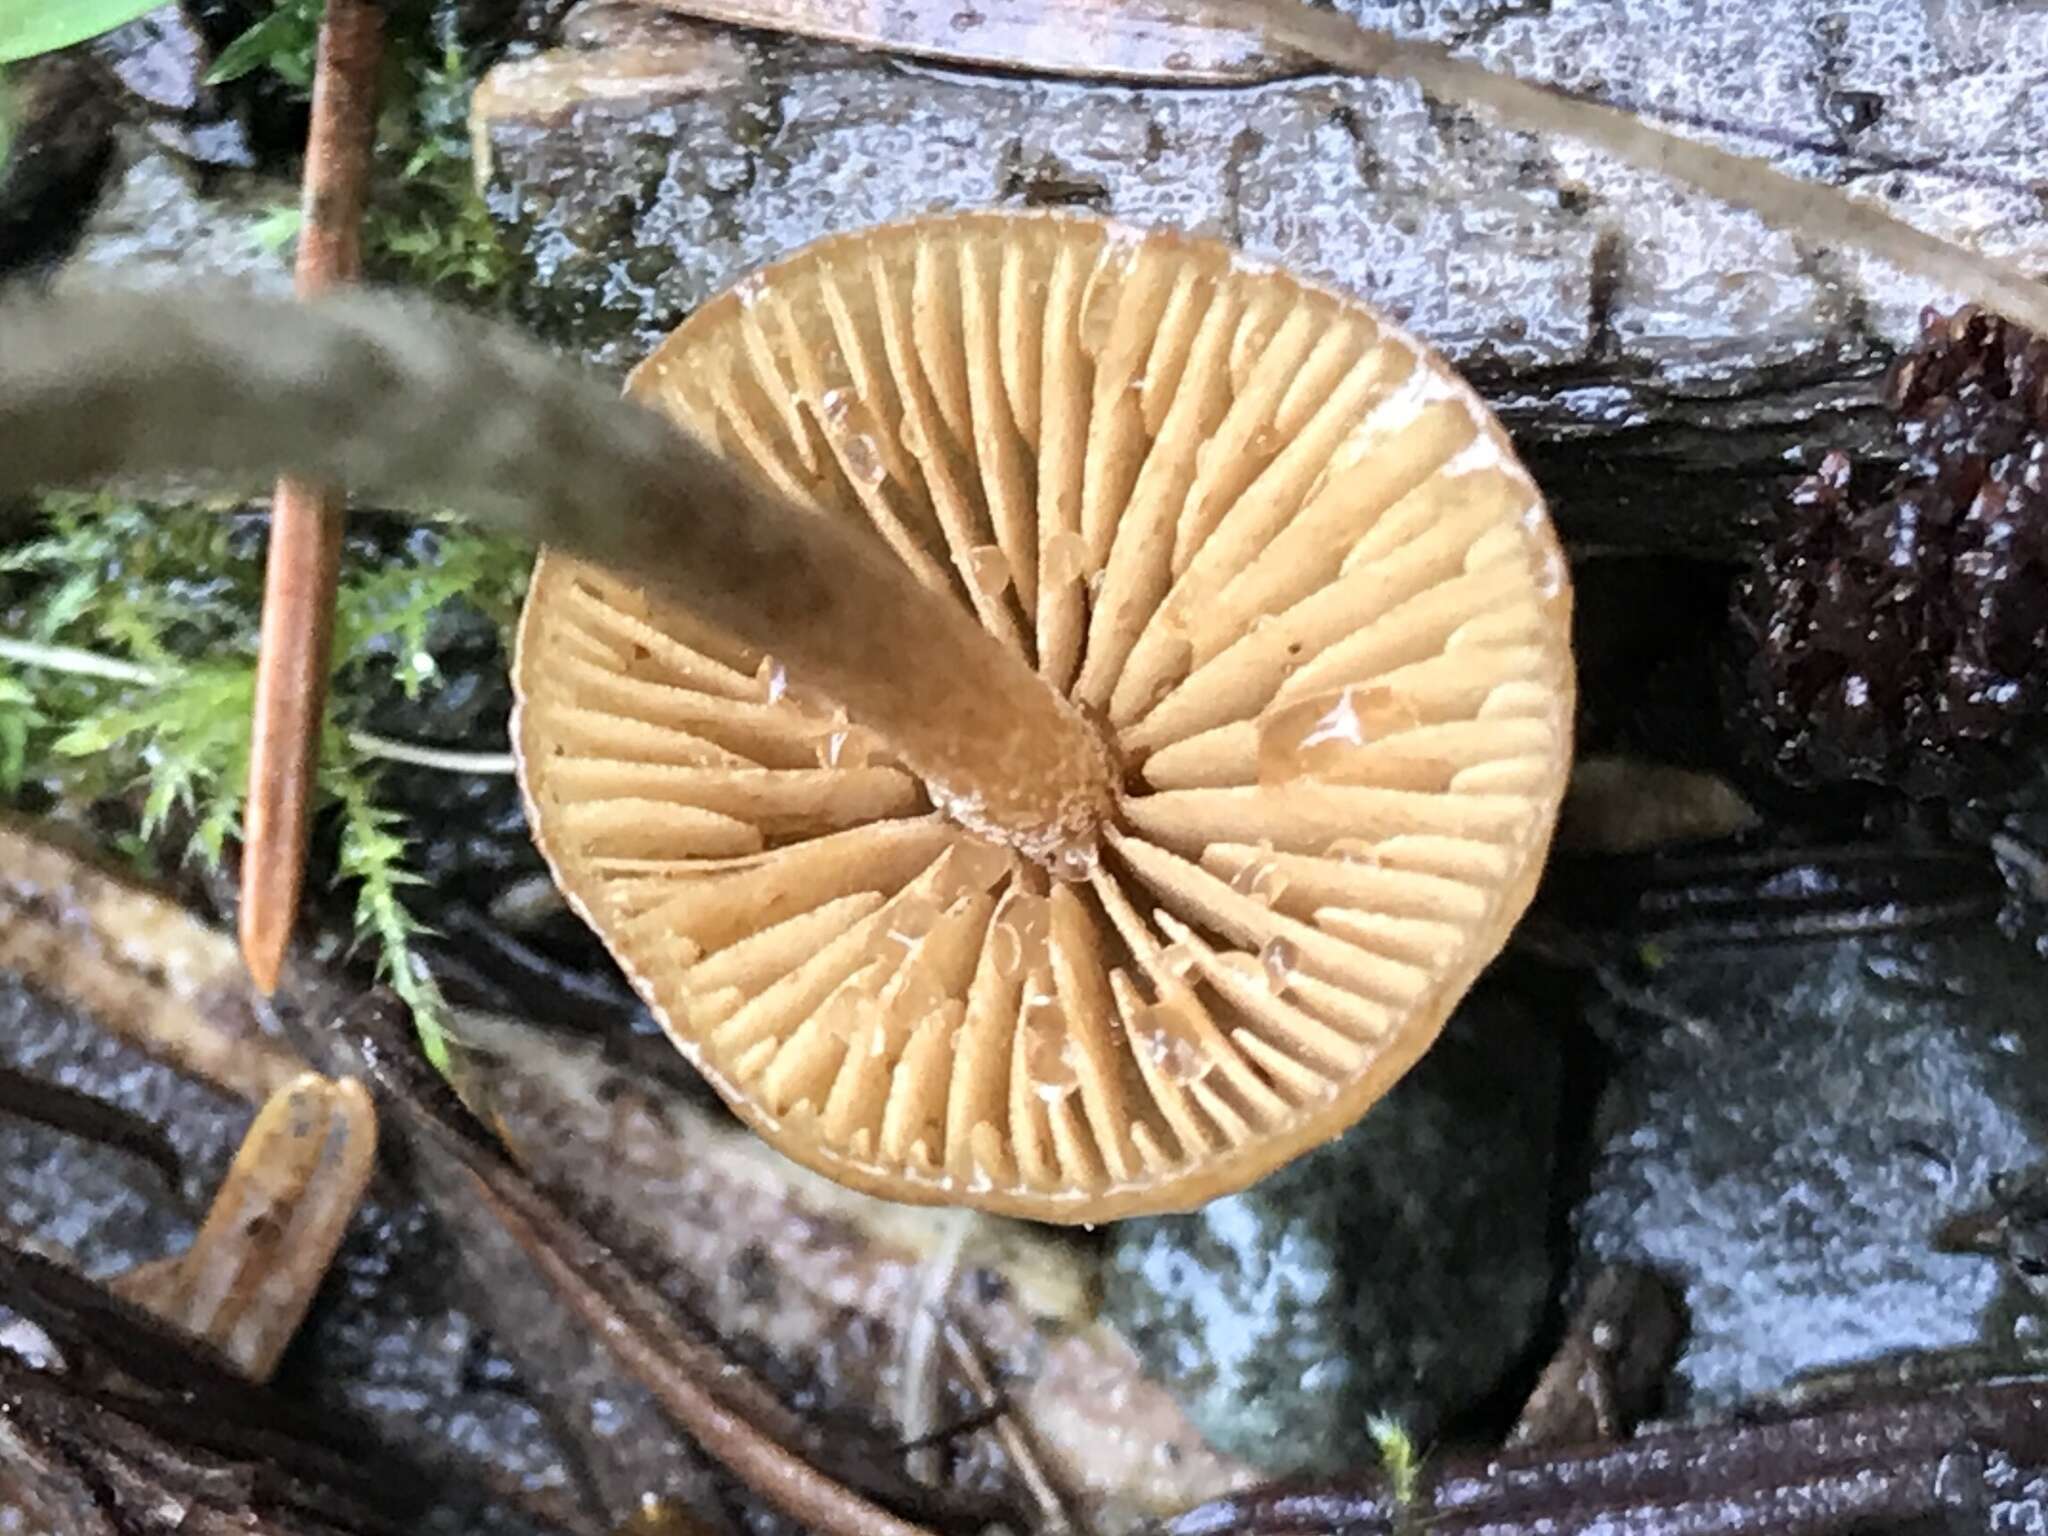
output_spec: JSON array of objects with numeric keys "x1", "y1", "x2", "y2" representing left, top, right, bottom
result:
[{"x1": 240, "y1": 0, "x2": 383, "y2": 991}]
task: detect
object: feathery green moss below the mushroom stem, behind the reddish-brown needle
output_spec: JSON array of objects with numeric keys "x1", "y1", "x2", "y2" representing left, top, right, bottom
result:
[{"x1": 0, "y1": 496, "x2": 530, "y2": 1059}]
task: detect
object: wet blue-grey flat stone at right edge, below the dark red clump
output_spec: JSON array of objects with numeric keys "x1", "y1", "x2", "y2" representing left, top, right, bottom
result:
[{"x1": 1575, "y1": 924, "x2": 2048, "y2": 1411}]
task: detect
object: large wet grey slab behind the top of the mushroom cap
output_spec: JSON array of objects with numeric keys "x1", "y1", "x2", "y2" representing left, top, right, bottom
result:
[{"x1": 473, "y1": 0, "x2": 2048, "y2": 549}]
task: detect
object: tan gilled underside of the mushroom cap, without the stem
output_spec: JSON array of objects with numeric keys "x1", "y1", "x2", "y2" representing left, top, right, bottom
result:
[{"x1": 514, "y1": 213, "x2": 1573, "y2": 1223}]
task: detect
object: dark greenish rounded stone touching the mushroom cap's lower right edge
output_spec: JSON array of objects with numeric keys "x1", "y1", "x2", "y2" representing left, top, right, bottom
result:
[{"x1": 1104, "y1": 989, "x2": 1563, "y2": 1473}]
